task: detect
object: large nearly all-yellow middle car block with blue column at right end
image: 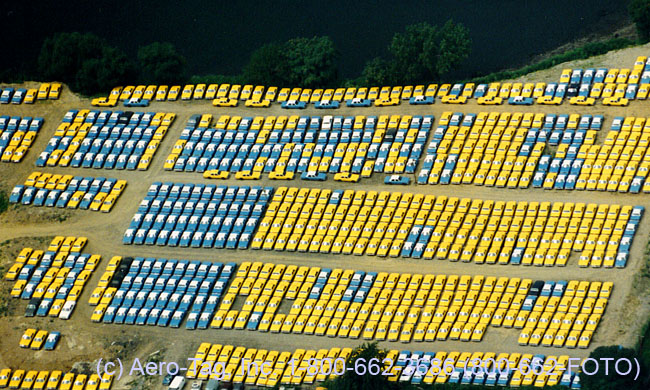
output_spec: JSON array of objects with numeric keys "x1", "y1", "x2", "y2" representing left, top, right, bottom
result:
[{"x1": 251, "y1": 187, "x2": 644, "y2": 267}]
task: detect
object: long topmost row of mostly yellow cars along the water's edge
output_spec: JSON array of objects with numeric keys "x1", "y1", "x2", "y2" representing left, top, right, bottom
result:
[{"x1": 93, "y1": 56, "x2": 650, "y2": 109}]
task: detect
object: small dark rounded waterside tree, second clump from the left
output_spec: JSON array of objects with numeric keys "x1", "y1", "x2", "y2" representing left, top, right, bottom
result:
[{"x1": 138, "y1": 42, "x2": 187, "y2": 84}]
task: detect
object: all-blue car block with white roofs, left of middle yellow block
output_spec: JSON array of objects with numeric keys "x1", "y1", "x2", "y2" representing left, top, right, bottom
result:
[{"x1": 122, "y1": 182, "x2": 273, "y2": 249}]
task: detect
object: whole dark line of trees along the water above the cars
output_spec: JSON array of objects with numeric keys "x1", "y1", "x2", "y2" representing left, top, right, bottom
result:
[{"x1": 12, "y1": 21, "x2": 471, "y2": 95}]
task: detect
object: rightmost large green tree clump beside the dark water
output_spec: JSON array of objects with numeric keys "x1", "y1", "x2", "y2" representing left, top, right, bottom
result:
[{"x1": 363, "y1": 20, "x2": 472, "y2": 85}]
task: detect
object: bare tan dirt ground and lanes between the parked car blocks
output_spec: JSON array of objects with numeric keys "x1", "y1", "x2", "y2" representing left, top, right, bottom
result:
[{"x1": 0, "y1": 45, "x2": 650, "y2": 389}]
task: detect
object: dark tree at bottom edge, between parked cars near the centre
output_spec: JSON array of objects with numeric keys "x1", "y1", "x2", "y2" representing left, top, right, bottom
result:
[{"x1": 323, "y1": 342, "x2": 396, "y2": 390}]
